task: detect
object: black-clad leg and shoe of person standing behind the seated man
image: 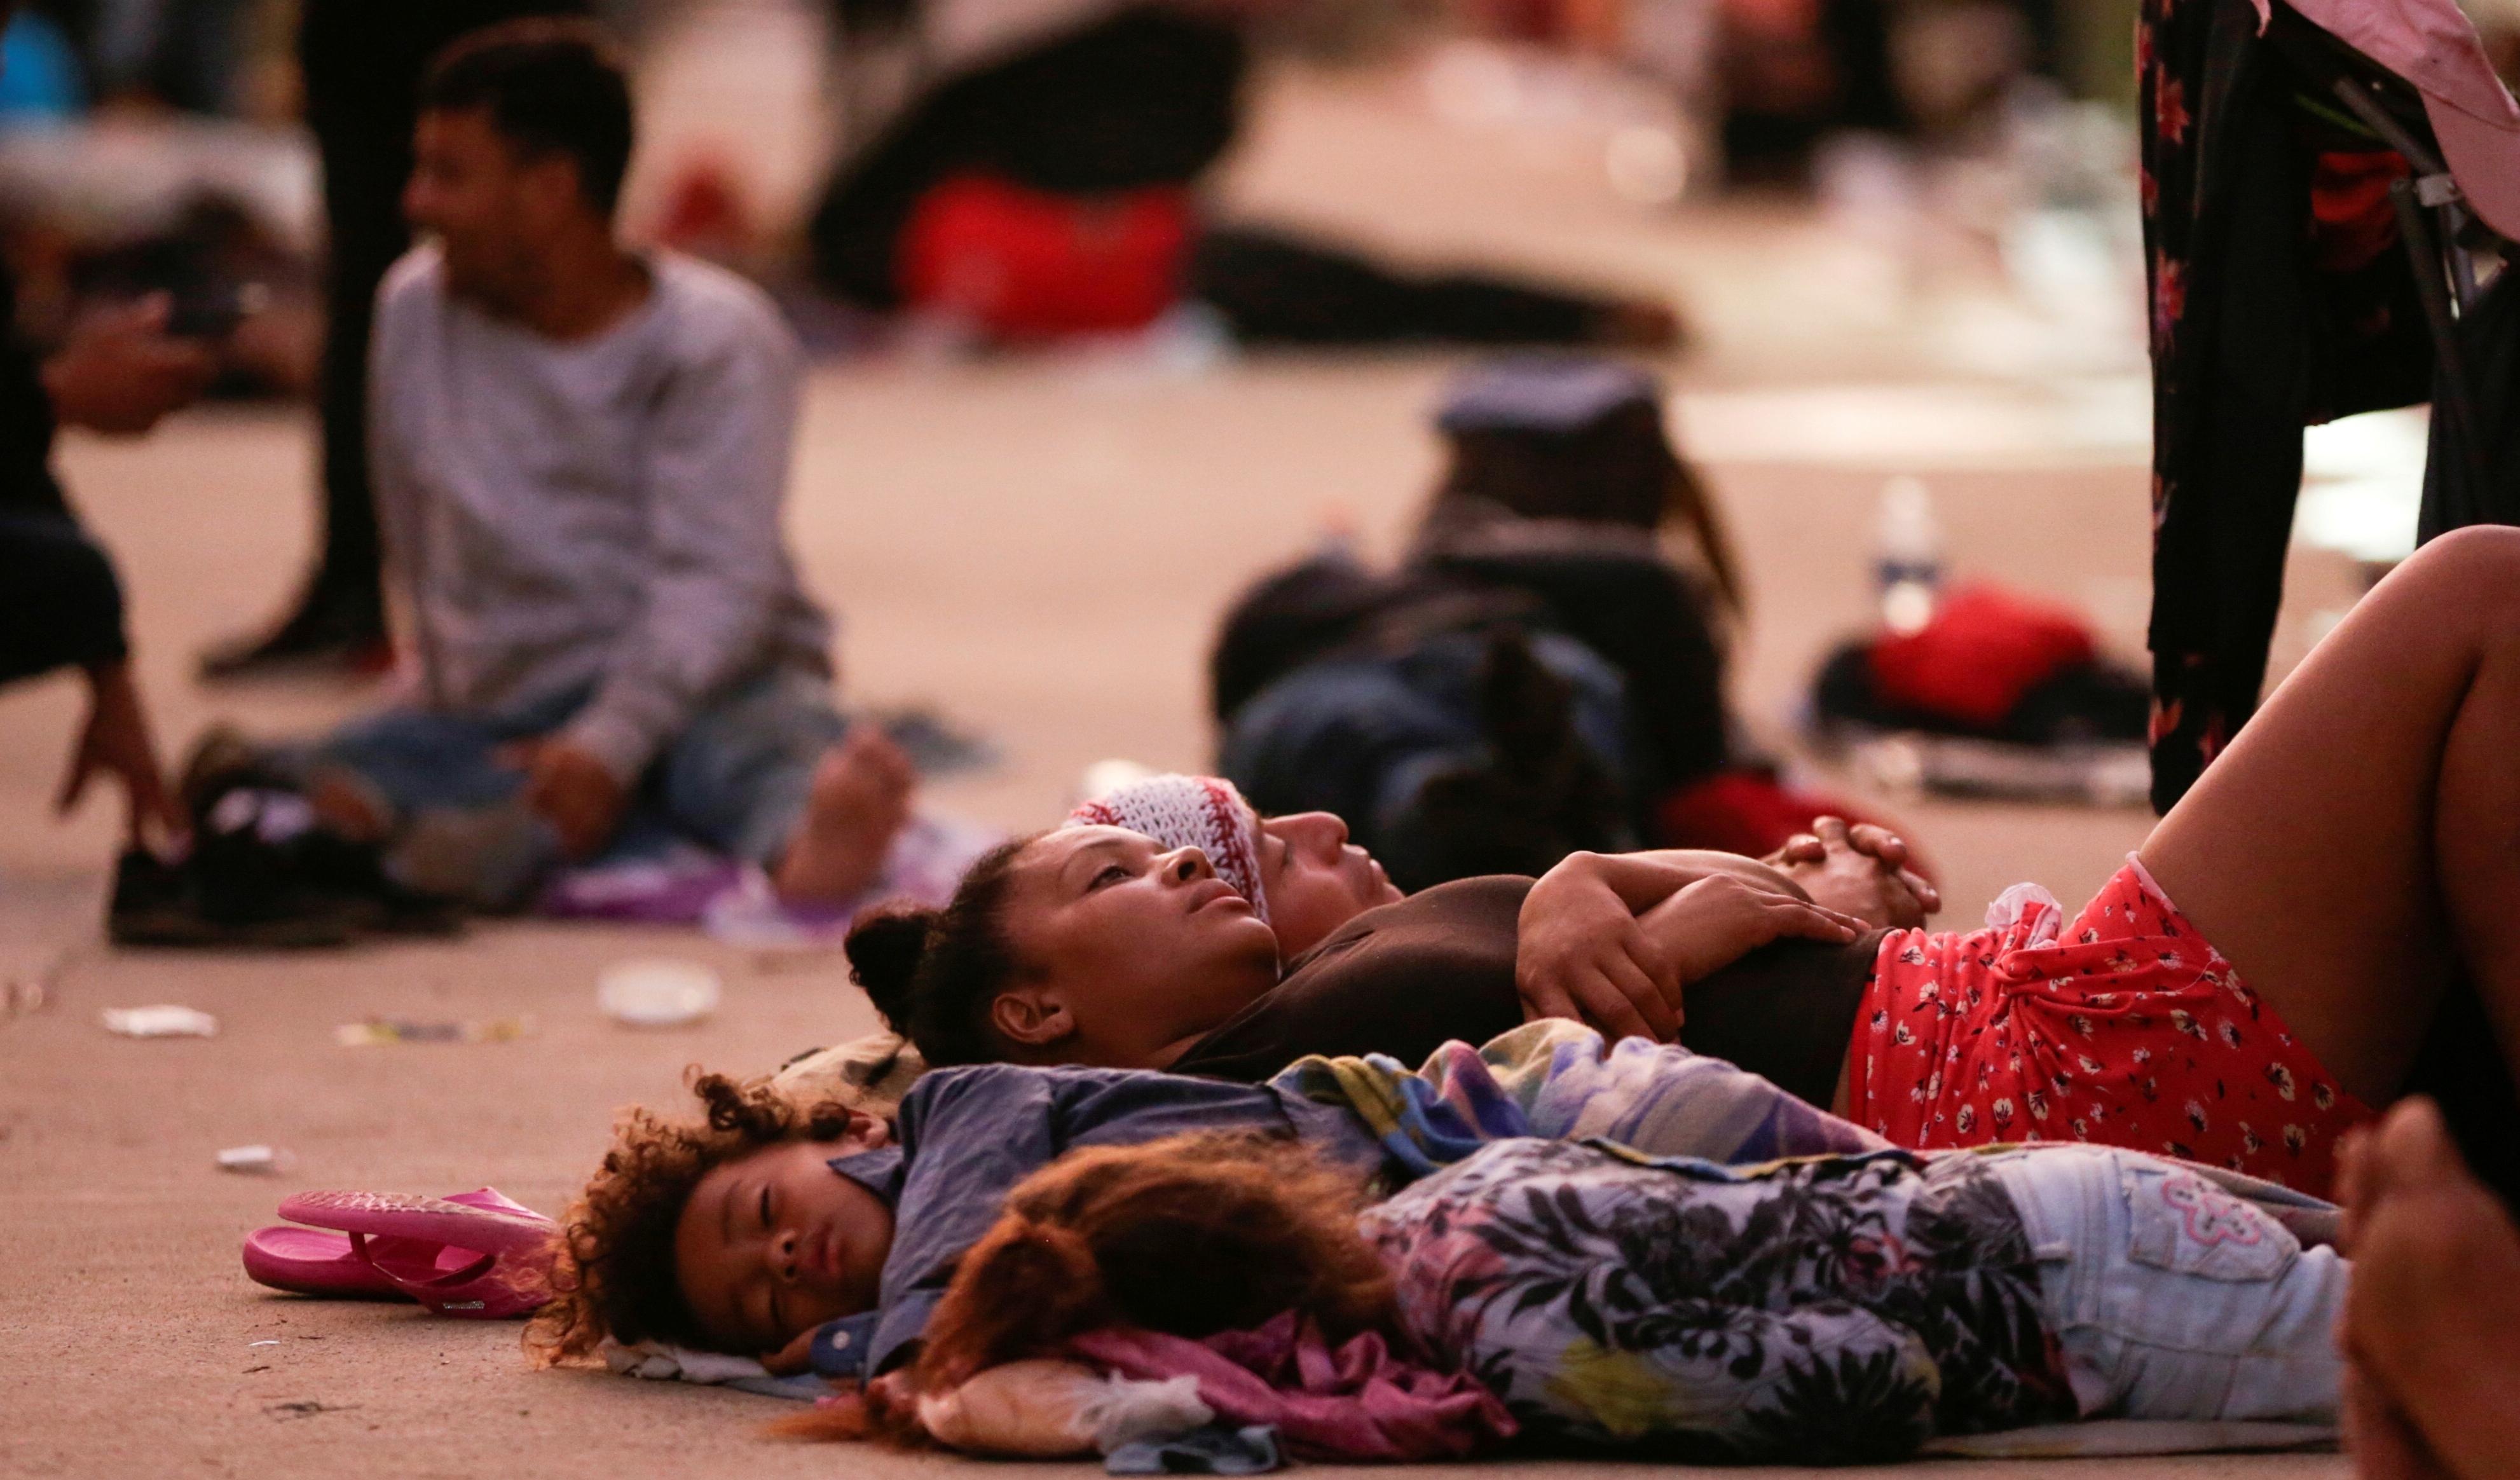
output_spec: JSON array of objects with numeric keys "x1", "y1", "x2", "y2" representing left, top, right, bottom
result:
[{"x1": 202, "y1": 0, "x2": 587, "y2": 678}]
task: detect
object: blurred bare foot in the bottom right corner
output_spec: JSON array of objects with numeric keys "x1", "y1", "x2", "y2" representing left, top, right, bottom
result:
[{"x1": 2339, "y1": 1099, "x2": 2520, "y2": 1480}]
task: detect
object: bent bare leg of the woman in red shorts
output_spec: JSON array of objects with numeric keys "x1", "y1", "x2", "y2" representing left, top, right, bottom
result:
[{"x1": 2142, "y1": 530, "x2": 2520, "y2": 1104}]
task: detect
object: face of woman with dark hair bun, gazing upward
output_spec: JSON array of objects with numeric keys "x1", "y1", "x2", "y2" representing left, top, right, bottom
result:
[{"x1": 990, "y1": 827, "x2": 1278, "y2": 1069}]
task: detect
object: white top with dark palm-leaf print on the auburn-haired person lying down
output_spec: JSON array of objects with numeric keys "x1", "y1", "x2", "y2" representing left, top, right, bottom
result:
[{"x1": 1361, "y1": 1140, "x2": 2076, "y2": 1462}]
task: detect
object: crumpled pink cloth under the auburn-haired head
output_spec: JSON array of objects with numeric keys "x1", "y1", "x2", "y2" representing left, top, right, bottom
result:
[{"x1": 1069, "y1": 1311, "x2": 1514, "y2": 1462}]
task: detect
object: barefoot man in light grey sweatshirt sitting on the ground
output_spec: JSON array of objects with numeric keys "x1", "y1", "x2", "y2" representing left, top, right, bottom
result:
[{"x1": 303, "y1": 20, "x2": 912, "y2": 905}]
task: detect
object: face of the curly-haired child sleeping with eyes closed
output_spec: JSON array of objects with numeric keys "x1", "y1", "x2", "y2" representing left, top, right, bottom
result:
[{"x1": 673, "y1": 1117, "x2": 892, "y2": 1352}]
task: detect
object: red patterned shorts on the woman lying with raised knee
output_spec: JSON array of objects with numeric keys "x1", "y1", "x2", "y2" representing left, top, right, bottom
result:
[{"x1": 1847, "y1": 860, "x2": 2371, "y2": 1198}]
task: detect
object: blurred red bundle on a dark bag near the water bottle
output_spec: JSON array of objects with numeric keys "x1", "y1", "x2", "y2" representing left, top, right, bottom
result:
[{"x1": 1872, "y1": 585, "x2": 2099, "y2": 731}]
